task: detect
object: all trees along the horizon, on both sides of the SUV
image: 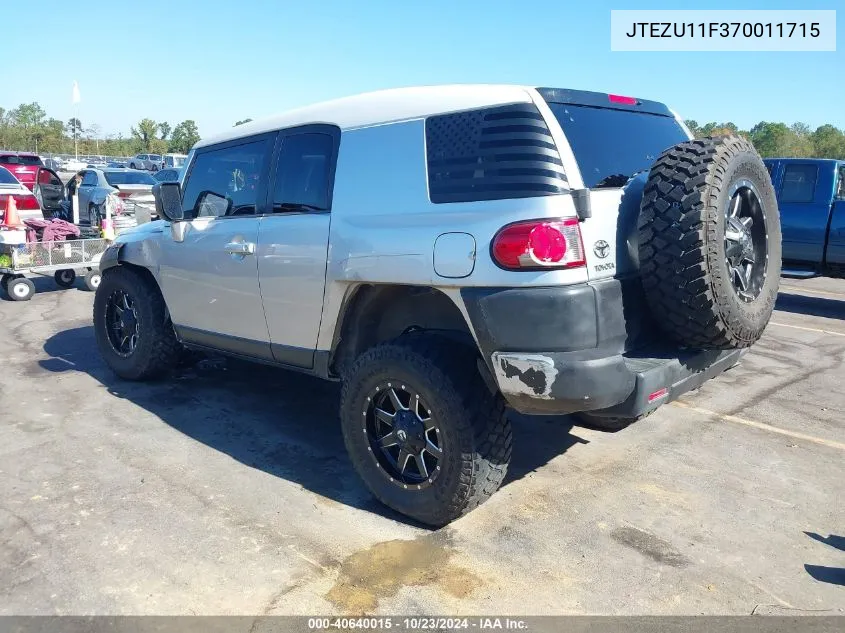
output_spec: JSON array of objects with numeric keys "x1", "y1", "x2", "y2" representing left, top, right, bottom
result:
[{"x1": 0, "y1": 102, "x2": 845, "y2": 160}]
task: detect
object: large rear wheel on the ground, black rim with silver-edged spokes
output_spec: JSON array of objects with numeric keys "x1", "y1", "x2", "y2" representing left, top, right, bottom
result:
[{"x1": 341, "y1": 335, "x2": 511, "y2": 526}]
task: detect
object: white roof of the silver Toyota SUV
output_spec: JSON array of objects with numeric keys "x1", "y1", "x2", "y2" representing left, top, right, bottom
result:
[{"x1": 195, "y1": 84, "x2": 531, "y2": 147}]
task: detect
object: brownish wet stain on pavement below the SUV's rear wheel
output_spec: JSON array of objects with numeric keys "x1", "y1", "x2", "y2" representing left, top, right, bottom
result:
[{"x1": 326, "y1": 533, "x2": 482, "y2": 613}]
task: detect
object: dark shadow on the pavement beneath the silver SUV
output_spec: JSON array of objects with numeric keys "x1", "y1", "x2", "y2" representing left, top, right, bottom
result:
[{"x1": 39, "y1": 326, "x2": 584, "y2": 525}]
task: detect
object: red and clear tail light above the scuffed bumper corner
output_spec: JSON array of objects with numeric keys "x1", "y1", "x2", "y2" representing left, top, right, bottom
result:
[{"x1": 491, "y1": 218, "x2": 587, "y2": 270}]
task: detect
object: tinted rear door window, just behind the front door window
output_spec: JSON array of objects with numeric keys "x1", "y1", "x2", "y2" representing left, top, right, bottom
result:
[{"x1": 273, "y1": 133, "x2": 334, "y2": 213}]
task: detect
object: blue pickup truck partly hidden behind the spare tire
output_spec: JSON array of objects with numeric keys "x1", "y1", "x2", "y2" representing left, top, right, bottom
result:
[{"x1": 764, "y1": 158, "x2": 845, "y2": 277}]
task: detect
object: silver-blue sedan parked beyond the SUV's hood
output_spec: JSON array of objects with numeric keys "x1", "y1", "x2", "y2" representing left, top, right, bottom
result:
[{"x1": 77, "y1": 169, "x2": 156, "y2": 226}]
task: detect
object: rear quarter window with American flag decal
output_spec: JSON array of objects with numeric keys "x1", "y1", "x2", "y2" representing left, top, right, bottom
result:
[{"x1": 425, "y1": 103, "x2": 568, "y2": 203}]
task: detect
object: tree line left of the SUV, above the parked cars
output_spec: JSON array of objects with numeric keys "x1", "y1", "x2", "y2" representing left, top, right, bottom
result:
[{"x1": 0, "y1": 102, "x2": 200, "y2": 156}]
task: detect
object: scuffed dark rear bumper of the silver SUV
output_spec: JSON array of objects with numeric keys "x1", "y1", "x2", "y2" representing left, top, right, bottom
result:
[{"x1": 461, "y1": 279, "x2": 745, "y2": 416}]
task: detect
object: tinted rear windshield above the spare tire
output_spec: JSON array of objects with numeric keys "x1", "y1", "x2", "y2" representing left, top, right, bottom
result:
[{"x1": 549, "y1": 103, "x2": 687, "y2": 189}]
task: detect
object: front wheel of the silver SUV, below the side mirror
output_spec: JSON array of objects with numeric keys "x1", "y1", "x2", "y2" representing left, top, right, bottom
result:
[{"x1": 94, "y1": 266, "x2": 181, "y2": 380}]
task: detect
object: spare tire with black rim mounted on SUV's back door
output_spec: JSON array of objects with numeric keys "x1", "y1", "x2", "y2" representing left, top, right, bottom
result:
[{"x1": 638, "y1": 136, "x2": 781, "y2": 349}]
